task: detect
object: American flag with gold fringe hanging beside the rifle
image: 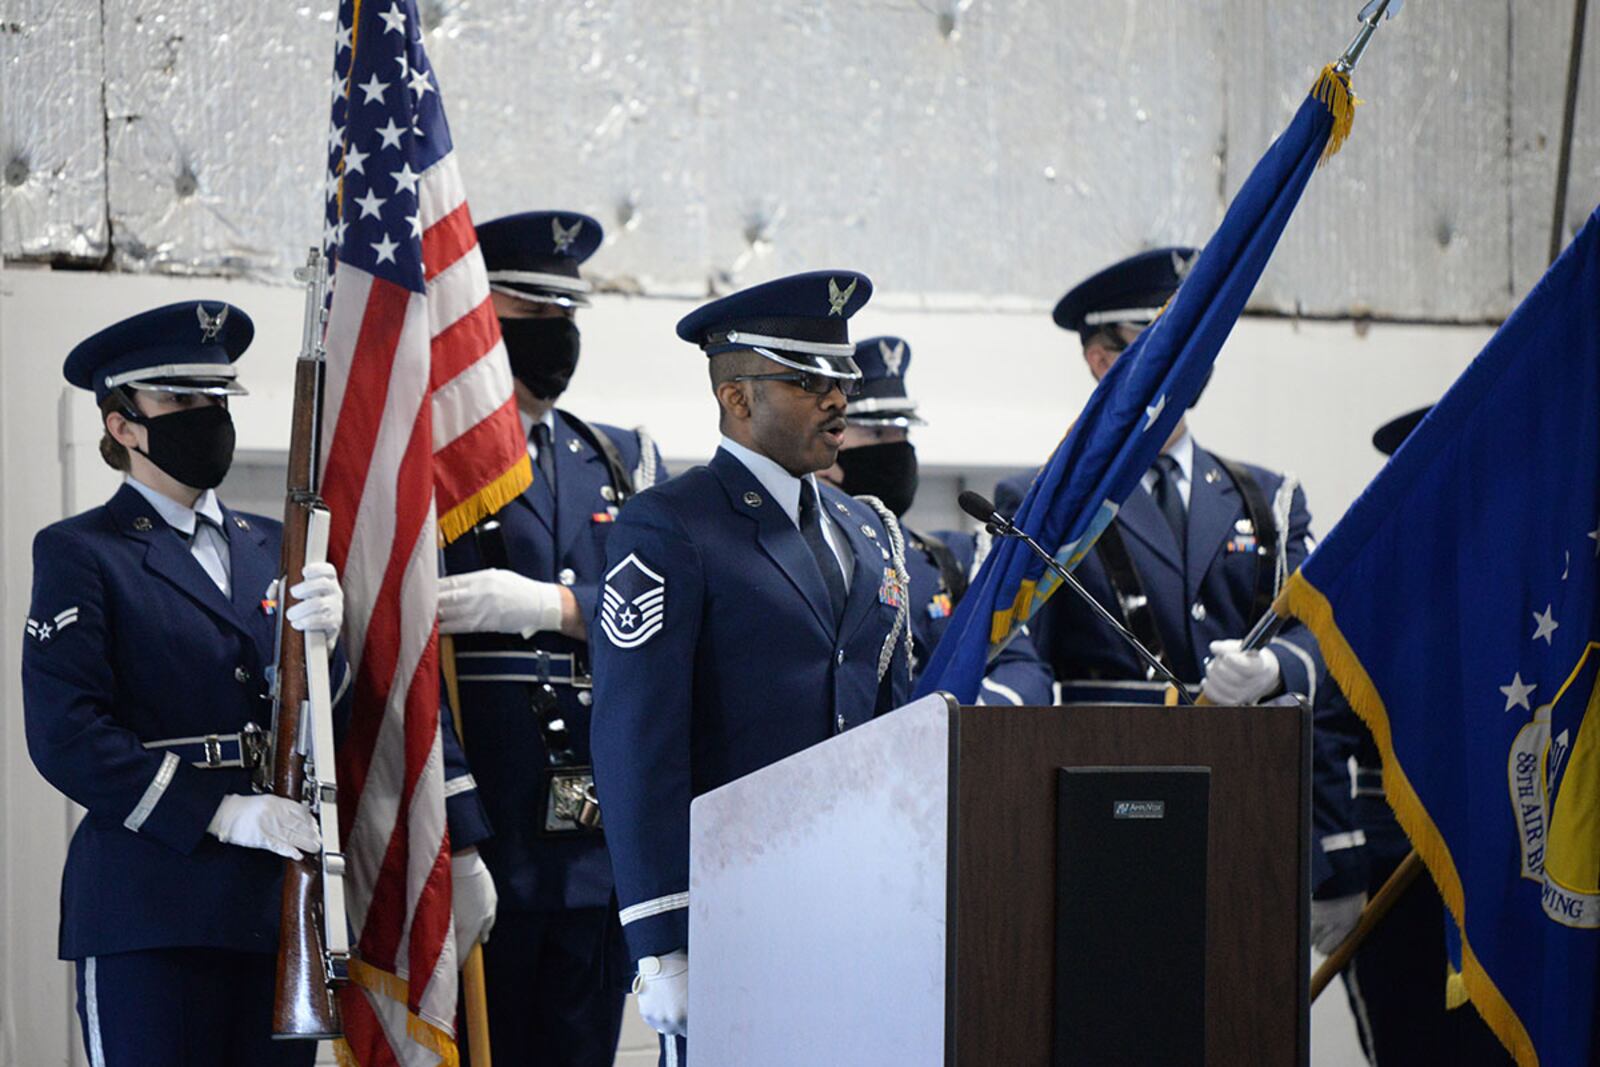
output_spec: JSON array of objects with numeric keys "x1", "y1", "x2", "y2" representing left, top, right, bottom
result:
[{"x1": 322, "y1": 0, "x2": 531, "y2": 1067}]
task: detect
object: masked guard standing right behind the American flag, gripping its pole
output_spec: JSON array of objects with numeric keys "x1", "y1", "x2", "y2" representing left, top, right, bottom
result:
[{"x1": 438, "y1": 211, "x2": 664, "y2": 1065}]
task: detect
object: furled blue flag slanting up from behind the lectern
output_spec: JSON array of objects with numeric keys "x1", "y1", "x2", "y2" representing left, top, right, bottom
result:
[{"x1": 917, "y1": 66, "x2": 1355, "y2": 704}]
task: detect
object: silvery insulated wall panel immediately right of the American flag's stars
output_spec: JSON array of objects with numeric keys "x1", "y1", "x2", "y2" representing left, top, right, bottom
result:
[{"x1": 424, "y1": 0, "x2": 707, "y2": 294}]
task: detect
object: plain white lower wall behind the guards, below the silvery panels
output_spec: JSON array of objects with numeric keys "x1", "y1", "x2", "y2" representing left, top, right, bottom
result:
[{"x1": 0, "y1": 260, "x2": 1488, "y2": 1067}]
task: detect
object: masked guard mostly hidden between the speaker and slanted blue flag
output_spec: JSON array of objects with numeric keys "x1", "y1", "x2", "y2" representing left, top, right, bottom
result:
[{"x1": 822, "y1": 338, "x2": 1056, "y2": 707}]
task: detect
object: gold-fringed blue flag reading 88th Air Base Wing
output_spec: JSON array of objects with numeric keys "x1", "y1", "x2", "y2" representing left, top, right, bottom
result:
[{"x1": 1278, "y1": 204, "x2": 1600, "y2": 1067}]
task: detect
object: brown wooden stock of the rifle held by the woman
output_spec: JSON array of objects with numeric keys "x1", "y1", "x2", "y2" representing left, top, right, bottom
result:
[{"x1": 272, "y1": 262, "x2": 341, "y2": 1040}]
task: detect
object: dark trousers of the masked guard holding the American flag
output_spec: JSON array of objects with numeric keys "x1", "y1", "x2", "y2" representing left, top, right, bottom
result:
[{"x1": 470, "y1": 907, "x2": 632, "y2": 1067}]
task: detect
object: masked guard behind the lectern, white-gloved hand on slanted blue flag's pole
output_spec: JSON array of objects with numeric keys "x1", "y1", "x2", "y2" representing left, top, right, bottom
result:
[{"x1": 995, "y1": 248, "x2": 1323, "y2": 704}]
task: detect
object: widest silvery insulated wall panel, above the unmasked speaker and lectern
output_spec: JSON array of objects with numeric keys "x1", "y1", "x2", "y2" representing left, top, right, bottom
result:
[{"x1": 702, "y1": 0, "x2": 1224, "y2": 307}]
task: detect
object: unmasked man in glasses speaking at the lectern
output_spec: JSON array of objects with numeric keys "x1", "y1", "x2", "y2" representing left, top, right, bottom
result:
[{"x1": 594, "y1": 270, "x2": 910, "y2": 1064}]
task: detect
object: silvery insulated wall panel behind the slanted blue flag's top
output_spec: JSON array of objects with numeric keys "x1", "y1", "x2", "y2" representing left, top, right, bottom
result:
[{"x1": 1227, "y1": 0, "x2": 1526, "y2": 320}]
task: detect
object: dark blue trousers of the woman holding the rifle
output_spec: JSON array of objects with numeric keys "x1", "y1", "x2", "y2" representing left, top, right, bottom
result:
[{"x1": 77, "y1": 949, "x2": 317, "y2": 1067}]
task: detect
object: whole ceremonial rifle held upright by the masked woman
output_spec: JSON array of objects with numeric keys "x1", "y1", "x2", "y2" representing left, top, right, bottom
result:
[{"x1": 269, "y1": 248, "x2": 350, "y2": 1040}]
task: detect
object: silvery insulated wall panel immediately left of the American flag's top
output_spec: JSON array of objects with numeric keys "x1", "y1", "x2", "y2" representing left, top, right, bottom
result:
[{"x1": 104, "y1": 0, "x2": 333, "y2": 278}]
